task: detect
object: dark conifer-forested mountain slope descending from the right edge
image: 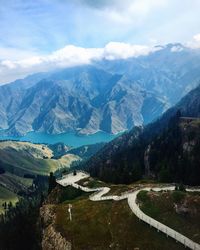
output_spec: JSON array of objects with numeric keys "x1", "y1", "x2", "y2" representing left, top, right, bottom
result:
[{"x1": 85, "y1": 86, "x2": 200, "y2": 185}]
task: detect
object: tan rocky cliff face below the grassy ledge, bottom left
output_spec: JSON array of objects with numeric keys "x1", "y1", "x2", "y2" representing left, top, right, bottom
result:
[{"x1": 40, "y1": 205, "x2": 72, "y2": 250}]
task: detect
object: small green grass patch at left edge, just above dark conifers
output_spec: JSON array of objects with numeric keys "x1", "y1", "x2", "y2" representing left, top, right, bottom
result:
[{"x1": 0, "y1": 186, "x2": 18, "y2": 214}]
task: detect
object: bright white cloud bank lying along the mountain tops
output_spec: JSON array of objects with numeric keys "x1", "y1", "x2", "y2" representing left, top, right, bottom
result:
[{"x1": 0, "y1": 42, "x2": 156, "y2": 83}]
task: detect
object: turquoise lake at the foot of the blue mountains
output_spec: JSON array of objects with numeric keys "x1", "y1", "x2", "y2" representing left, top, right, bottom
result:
[{"x1": 0, "y1": 131, "x2": 119, "y2": 147}]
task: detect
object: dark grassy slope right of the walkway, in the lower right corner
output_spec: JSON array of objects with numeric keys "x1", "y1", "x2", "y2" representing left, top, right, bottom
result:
[{"x1": 138, "y1": 191, "x2": 200, "y2": 243}]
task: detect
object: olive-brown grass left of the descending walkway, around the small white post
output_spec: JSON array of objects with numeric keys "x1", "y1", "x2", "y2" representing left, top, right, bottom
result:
[{"x1": 55, "y1": 198, "x2": 184, "y2": 250}]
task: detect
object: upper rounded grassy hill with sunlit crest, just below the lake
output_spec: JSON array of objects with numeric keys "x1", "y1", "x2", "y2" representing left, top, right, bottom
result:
[{"x1": 0, "y1": 141, "x2": 80, "y2": 176}]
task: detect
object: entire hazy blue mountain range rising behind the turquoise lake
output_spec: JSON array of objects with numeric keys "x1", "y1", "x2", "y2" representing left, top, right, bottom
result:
[{"x1": 0, "y1": 44, "x2": 200, "y2": 136}]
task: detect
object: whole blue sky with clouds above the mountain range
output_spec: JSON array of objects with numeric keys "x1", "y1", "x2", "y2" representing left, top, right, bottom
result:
[{"x1": 0, "y1": 0, "x2": 200, "y2": 84}]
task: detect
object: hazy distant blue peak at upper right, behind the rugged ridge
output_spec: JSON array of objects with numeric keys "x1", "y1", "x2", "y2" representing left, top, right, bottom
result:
[{"x1": 98, "y1": 44, "x2": 200, "y2": 105}]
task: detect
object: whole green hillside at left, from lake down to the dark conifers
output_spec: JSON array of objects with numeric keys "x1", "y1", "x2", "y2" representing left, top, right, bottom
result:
[{"x1": 0, "y1": 141, "x2": 80, "y2": 213}]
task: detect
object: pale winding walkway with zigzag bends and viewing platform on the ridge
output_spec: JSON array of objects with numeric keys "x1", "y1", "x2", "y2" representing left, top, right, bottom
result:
[{"x1": 57, "y1": 171, "x2": 200, "y2": 250}]
